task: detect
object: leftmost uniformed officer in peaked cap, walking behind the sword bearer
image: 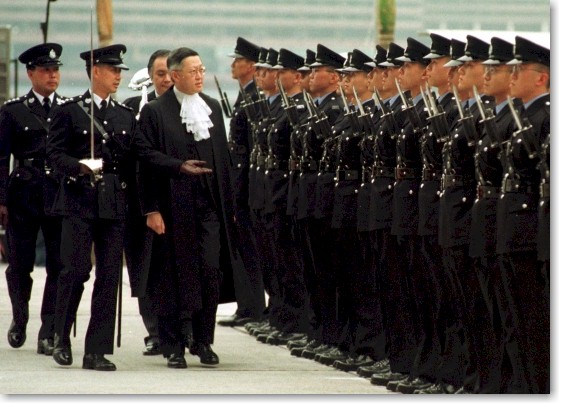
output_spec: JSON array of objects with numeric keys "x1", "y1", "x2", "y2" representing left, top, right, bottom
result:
[{"x1": 0, "y1": 43, "x2": 63, "y2": 355}]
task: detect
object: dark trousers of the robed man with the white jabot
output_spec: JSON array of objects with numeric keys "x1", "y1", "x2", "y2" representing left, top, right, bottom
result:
[{"x1": 158, "y1": 207, "x2": 222, "y2": 357}]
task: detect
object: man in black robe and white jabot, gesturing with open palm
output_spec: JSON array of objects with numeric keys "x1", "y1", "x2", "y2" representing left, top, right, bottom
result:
[{"x1": 135, "y1": 47, "x2": 235, "y2": 368}]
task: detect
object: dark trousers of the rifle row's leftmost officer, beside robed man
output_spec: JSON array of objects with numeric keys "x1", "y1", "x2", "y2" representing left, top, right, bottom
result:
[{"x1": 233, "y1": 207, "x2": 265, "y2": 319}]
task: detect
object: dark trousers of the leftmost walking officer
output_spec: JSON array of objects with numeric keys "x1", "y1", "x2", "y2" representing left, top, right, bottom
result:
[{"x1": 6, "y1": 207, "x2": 63, "y2": 339}]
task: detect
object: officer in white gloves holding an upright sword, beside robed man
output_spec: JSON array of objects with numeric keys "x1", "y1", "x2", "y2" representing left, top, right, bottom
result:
[{"x1": 47, "y1": 44, "x2": 136, "y2": 371}]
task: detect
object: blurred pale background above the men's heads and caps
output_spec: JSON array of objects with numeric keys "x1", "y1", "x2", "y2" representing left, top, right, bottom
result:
[{"x1": 0, "y1": 0, "x2": 550, "y2": 103}]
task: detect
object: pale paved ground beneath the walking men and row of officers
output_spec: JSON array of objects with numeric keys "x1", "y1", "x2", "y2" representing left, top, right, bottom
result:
[{"x1": 0, "y1": 264, "x2": 397, "y2": 396}]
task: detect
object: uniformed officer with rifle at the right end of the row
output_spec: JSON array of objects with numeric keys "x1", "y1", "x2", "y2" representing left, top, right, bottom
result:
[{"x1": 496, "y1": 36, "x2": 550, "y2": 393}]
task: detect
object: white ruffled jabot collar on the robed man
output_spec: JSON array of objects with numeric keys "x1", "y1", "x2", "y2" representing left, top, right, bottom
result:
[{"x1": 173, "y1": 87, "x2": 214, "y2": 141}]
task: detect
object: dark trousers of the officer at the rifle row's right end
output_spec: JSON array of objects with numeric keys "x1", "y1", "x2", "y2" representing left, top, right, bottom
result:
[{"x1": 499, "y1": 250, "x2": 550, "y2": 393}]
